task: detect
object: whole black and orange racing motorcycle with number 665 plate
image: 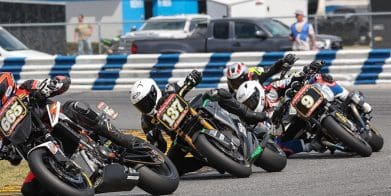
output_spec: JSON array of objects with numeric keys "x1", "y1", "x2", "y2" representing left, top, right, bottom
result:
[{"x1": 0, "y1": 91, "x2": 178, "y2": 196}]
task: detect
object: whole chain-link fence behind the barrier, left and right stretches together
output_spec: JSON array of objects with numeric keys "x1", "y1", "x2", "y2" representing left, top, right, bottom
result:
[{"x1": 0, "y1": 12, "x2": 391, "y2": 55}]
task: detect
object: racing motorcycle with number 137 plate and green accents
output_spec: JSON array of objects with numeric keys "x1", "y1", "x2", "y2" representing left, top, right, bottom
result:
[{"x1": 156, "y1": 84, "x2": 286, "y2": 177}]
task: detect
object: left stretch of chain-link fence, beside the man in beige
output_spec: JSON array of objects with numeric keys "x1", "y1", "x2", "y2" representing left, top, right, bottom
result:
[{"x1": 0, "y1": 21, "x2": 144, "y2": 55}]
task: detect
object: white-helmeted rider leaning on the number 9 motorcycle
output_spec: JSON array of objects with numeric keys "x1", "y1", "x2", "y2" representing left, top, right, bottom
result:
[{"x1": 236, "y1": 61, "x2": 371, "y2": 156}]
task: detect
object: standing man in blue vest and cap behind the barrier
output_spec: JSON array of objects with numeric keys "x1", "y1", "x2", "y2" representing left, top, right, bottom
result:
[{"x1": 289, "y1": 10, "x2": 316, "y2": 51}]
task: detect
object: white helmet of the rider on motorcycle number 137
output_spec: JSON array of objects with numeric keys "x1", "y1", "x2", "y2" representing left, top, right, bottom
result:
[{"x1": 130, "y1": 79, "x2": 162, "y2": 114}]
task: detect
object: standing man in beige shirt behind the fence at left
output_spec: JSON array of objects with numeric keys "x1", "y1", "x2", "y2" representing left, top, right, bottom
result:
[{"x1": 74, "y1": 14, "x2": 92, "y2": 55}]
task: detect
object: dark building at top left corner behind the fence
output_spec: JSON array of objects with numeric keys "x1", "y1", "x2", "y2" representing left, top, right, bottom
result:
[{"x1": 0, "y1": 0, "x2": 66, "y2": 54}]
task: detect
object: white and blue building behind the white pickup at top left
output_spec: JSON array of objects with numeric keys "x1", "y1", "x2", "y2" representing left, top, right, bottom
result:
[{"x1": 62, "y1": 0, "x2": 202, "y2": 42}]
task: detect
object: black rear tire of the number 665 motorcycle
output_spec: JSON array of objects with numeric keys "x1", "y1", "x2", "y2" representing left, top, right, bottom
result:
[{"x1": 136, "y1": 142, "x2": 179, "y2": 195}]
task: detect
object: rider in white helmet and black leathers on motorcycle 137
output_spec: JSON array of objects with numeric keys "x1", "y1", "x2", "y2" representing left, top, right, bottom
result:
[{"x1": 130, "y1": 70, "x2": 272, "y2": 175}]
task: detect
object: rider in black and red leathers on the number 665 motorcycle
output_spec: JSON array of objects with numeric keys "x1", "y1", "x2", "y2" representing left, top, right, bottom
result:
[{"x1": 0, "y1": 72, "x2": 142, "y2": 196}]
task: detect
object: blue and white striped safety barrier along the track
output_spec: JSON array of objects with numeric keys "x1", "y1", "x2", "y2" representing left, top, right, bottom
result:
[{"x1": 0, "y1": 49, "x2": 391, "y2": 90}]
